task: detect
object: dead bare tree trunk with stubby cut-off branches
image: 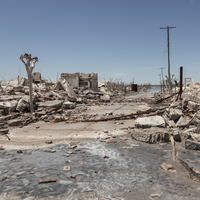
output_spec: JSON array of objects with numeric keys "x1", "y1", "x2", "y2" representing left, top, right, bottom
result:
[{"x1": 19, "y1": 53, "x2": 38, "y2": 112}]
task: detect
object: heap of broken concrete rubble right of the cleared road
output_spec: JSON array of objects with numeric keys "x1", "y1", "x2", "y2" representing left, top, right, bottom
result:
[{"x1": 131, "y1": 80, "x2": 200, "y2": 150}]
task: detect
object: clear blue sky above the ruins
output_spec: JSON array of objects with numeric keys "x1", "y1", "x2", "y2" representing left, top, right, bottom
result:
[{"x1": 0, "y1": 0, "x2": 200, "y2": 84}]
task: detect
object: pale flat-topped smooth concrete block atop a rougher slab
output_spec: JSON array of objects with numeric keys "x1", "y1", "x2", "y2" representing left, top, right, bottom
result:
[{"x1": 135, "y1": 116, "x2": 165, "y2": 128}]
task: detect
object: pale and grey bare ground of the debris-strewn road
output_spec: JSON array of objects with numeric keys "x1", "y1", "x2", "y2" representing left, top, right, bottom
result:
[{"x1": 0, "y1": 93, "x2": 200, "y2": 200}]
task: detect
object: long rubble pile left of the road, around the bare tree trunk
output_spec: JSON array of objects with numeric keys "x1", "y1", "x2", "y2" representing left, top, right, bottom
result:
[{"x1": 0, "y1": 73, "x2": 130, "y2": 131}]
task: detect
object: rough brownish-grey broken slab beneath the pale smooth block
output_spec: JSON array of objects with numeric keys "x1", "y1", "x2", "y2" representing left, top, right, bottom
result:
[{"x1": 131, "y1": 129, "x2": 169, "y2": 144}]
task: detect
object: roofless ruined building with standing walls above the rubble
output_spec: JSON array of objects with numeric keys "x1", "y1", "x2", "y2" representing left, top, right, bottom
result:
[{"x1": 61, "y1": 72, "x2": 98, "y2": 92}]
